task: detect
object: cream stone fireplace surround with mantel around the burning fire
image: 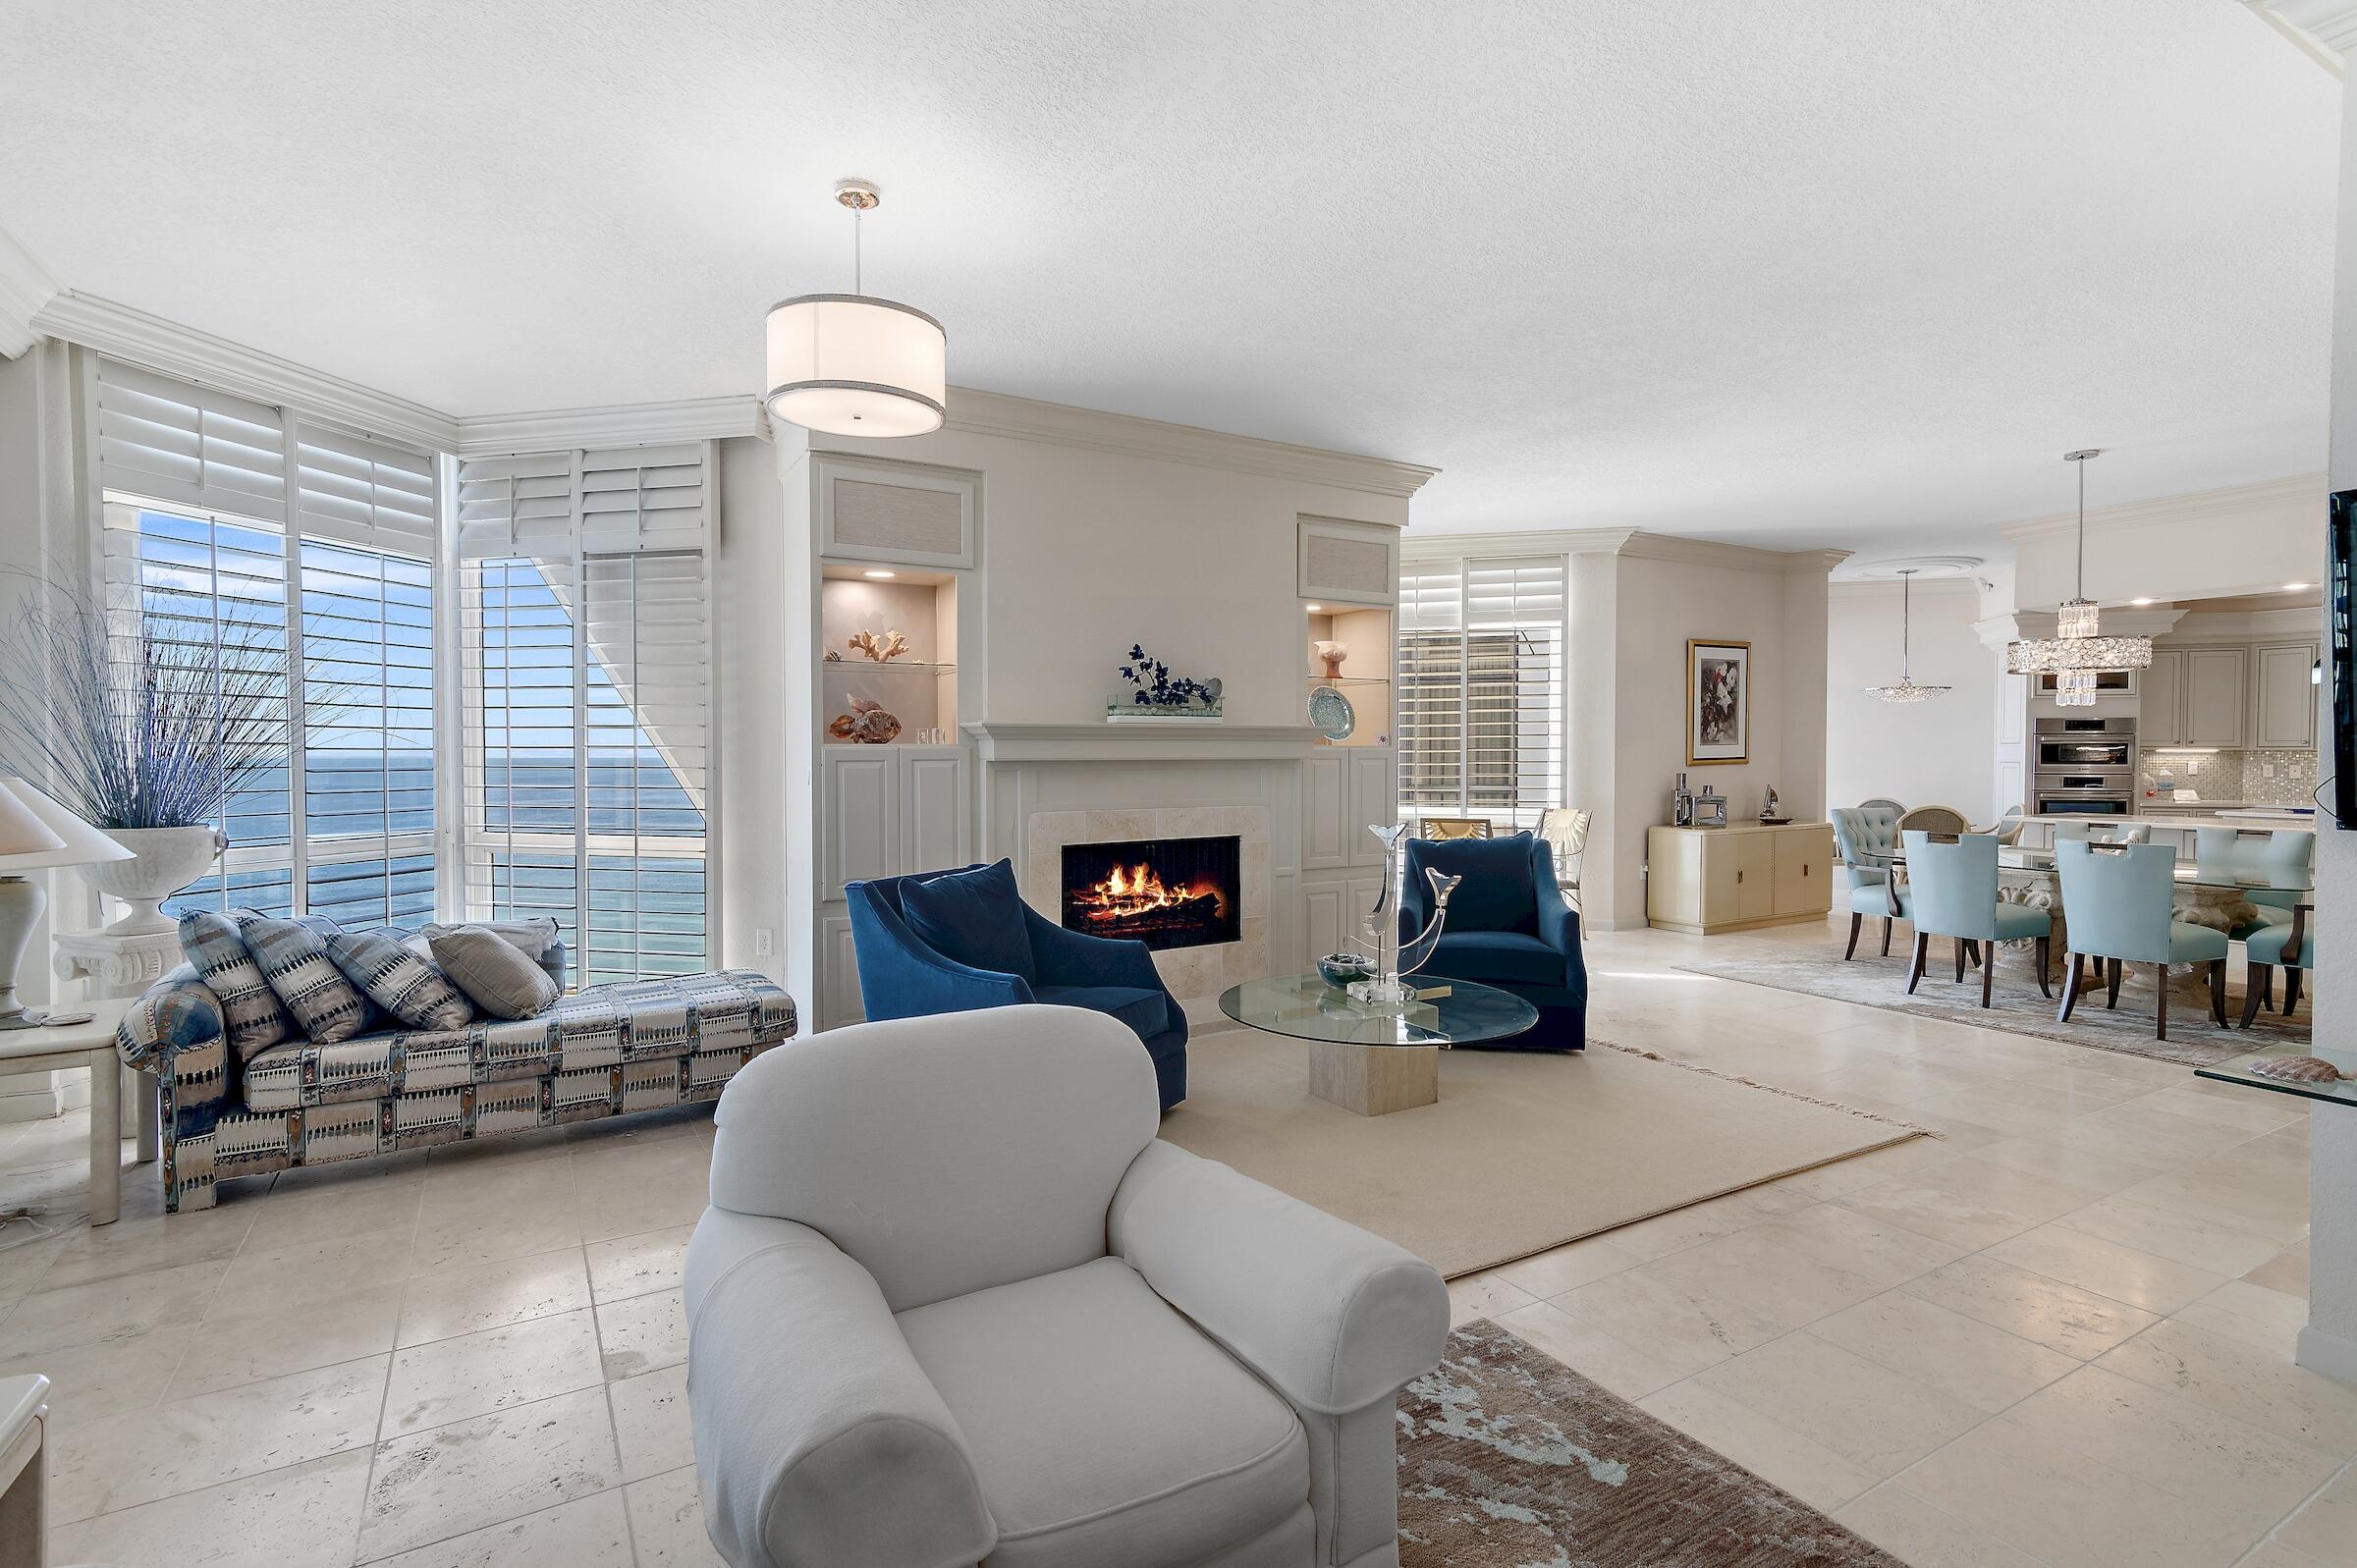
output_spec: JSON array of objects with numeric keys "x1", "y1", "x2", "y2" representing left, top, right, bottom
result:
[{"x1": 966, "y1": 724, "x2": 1318, "y2": 1023}]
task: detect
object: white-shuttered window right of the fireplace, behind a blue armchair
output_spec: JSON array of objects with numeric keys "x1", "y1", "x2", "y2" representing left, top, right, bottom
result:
[{"x1": 1396, "y1": 559, "x2": 1565, "y2": 828}]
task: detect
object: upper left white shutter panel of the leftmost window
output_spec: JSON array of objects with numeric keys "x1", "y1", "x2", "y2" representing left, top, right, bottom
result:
[{"x1": 96, "y1": 358, "x2": 288, "y2": 523}]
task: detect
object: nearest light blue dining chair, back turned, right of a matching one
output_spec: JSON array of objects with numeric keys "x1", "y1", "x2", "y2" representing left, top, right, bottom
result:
[{"x1": 2056, "y1": 839, "x2": 2227, "y2": 1040}]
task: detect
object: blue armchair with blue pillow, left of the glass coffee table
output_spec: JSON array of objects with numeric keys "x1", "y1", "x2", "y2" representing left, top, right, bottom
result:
[{"x1": 844, "y1": 861, "x2": 1185, "y2": 1110}]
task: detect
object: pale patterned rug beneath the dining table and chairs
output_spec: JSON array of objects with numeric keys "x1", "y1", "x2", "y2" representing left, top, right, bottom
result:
[{"x1": 1680, "y1": 927, "x2": 2315, "y2": 1068}]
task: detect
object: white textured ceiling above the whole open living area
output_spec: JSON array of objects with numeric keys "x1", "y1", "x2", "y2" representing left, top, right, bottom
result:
[{"x1": 0, "y1": 0, "x2": 2340, "y2": 552}]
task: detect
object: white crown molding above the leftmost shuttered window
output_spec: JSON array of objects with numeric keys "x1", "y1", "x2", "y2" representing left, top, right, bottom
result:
[{"x1": 33, "y1": 290, "x2": 458, "y2": 453}]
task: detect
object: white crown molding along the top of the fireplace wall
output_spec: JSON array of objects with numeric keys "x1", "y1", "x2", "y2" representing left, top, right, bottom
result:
[{"x1": 943, "y1": 387, "x2": 1440, "y2": 500}]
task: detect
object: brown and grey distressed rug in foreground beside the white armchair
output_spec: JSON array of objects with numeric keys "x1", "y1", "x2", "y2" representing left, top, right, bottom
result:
[{"x1": 1400, "y1": 1321, "x2": 1907, "y2": 1568}]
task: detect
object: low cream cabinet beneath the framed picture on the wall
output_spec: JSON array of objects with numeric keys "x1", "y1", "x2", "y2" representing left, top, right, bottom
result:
[{"x1": 1645, "y1": 823, "x2": 1834, "y2": 936}]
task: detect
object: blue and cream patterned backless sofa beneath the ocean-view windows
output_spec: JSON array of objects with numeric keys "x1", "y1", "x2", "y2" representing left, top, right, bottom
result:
[{"x1": 116, "y1": 944, "x2": 795, "y2": 1215}]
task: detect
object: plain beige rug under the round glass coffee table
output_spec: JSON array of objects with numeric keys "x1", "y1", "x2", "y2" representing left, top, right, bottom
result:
[{"x1": 1162, "y1": 1028, "x2": 1921, "y2": 1278}]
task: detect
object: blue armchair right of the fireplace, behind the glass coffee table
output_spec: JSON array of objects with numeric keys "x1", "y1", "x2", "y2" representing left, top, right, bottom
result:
[{"x1": 1400, "y1": 833, "x2": 1589, "y2": 1052}]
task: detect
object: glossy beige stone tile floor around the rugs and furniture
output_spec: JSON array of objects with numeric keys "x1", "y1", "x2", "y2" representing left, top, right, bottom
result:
[{"x1": 0, "y1": 927, "x2": 2357, "y2": 1568}]
